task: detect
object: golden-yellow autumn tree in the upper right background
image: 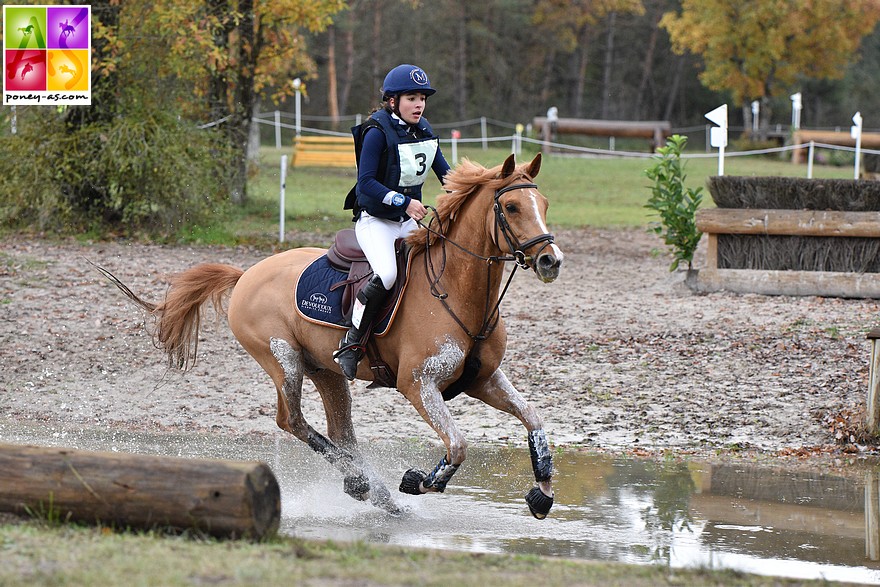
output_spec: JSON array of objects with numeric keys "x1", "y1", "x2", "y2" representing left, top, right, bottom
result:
[{"x1": 660, "y1": 0, "x2": 880, "y2": 137}]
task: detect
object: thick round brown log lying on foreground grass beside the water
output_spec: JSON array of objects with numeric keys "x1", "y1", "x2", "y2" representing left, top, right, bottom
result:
[{"x1": 0, "y1": 444, "x2": 281, "y2": 539}]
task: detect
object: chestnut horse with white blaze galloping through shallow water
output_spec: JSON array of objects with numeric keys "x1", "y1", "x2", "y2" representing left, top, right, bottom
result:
[{"x1": 104, "y1": 154, "x2": 563, "y2": 519}]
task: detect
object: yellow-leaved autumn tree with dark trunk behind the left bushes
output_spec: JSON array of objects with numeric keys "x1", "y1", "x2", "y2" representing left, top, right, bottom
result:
[{"x1": 153, "y1": 0, "x2": 345, "y2": 203}]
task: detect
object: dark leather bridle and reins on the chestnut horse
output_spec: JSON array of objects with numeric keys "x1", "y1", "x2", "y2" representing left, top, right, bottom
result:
[{"x1": 419, "y1": 183, "x2": 554, "y2": 342}]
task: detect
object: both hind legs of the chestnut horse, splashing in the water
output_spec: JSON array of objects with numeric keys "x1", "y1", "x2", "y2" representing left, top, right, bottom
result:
[{"x1": 267, "y1": 338, "x2": 400, "y2": 514}]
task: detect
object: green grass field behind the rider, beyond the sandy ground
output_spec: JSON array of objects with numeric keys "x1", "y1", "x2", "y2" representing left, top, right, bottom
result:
[{"x1": 232, "y1": 146, "x2": 852, "y2": 244}]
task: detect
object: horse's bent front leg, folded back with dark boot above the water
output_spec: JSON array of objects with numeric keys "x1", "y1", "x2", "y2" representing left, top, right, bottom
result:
[{"x1": 399, "y1": 341, "x2": 467, "y2": 495}]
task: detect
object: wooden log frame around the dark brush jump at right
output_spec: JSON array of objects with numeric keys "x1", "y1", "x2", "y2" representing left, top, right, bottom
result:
[{"x1": 688, "y1": 208, "x2": 880, "y2": 298}]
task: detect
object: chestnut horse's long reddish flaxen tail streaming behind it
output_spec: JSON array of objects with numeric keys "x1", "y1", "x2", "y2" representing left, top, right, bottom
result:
[{"x1": 89, "y1": 261, "x2": 244, "y2": 371}]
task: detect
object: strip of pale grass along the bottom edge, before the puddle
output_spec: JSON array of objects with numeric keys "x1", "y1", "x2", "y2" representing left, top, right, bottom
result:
[{"x1": 0, "y1": 522, "x2": 840, "y2": 587}]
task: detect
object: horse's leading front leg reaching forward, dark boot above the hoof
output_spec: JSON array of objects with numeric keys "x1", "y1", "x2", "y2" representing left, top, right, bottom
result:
[{"x1": 466, "y1": 369, "x2": 553, "y2": 520}]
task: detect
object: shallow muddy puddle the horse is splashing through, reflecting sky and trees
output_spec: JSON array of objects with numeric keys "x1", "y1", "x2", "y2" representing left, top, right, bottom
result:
[{"x1": 0, "y1": 424, "x2": 880, "y2": 584}]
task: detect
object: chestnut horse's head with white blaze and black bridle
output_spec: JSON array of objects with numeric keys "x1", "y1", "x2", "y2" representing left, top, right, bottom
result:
[{"x1": 489, "y1": 153, "x2": 563, "y2": 282}]
